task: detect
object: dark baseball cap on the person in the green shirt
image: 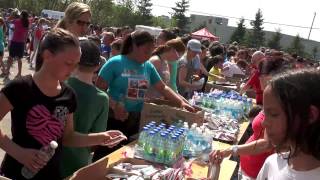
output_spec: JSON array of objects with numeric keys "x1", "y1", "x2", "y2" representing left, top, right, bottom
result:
[{"x1": 79, "y1": 38, "x2": 101, "y2": 67}]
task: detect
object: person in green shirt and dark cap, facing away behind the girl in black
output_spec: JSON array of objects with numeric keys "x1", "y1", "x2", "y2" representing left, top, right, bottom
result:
[{"x1": 60, "y1": 39, "x2": 126, "y2": 178}]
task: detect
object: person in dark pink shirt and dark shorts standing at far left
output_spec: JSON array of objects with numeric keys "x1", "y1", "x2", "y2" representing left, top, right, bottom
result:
[{"x1": 6, "y1": 11, "x2": 29, "y2": 78}]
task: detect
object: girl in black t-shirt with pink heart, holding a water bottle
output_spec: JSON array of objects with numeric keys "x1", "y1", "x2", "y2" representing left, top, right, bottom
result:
[{"x1": 0, "y1": 28, "x2": 125, "y2": 179}]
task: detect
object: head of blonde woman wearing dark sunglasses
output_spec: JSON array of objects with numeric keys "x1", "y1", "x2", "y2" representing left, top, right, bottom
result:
[{"x1": 56, "y1": 2, "x2": 91, "y2": 37}]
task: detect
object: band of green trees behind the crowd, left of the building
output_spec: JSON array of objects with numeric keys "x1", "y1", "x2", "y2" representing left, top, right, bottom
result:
[{"x1": 0, "y1": 0, "x2": 181, "y2": 28}]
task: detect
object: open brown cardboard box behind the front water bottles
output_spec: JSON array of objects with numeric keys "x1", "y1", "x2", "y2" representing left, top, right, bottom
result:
[{"x1": 140, "y1": 99, "x2": 204, "y2": 129}]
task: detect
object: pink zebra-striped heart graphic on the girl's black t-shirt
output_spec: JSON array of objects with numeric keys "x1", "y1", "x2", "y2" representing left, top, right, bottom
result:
[{"x1": 26, "y1": 105, "x2": 68, "y2": 146}]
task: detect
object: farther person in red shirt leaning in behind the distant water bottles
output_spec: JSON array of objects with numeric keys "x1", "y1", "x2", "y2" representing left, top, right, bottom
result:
[{"x1": 240, "y1": 51, "x2": 265, "y2": 105}]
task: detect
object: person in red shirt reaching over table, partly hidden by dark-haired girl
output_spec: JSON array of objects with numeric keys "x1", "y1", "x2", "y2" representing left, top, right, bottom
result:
[{"x1": 210, "y1": 59, "x2": 286, "y2": 179}]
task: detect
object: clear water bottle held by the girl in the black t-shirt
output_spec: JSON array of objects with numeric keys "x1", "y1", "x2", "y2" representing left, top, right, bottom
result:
[{"x1": 21, "y1": 141, "x2": 58, "y2": 179}]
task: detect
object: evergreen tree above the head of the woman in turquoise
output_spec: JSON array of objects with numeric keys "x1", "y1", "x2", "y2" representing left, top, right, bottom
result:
[{"x1": 137, "y1": 0, "x2": 153, "y2": 26}]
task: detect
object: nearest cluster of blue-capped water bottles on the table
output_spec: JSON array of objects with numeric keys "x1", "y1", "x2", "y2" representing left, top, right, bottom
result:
[{"x1": 137, "y1": 121, "x2": 212, "y2": 165}]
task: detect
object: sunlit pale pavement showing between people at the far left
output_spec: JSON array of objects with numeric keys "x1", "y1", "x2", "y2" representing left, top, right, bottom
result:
[{"x1": 0, "y1": 52, "x2": 33, "y2": 163}]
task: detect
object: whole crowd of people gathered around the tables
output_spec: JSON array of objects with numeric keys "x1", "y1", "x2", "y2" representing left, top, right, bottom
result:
[{"x1": 0, "y1": 2, "x2": 320, "y2": 179}]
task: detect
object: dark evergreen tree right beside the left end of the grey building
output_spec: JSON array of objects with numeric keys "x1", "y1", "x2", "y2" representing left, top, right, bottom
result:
[{"x1": 172, "y1": 0, "x2": 189, "y2": 31}]
